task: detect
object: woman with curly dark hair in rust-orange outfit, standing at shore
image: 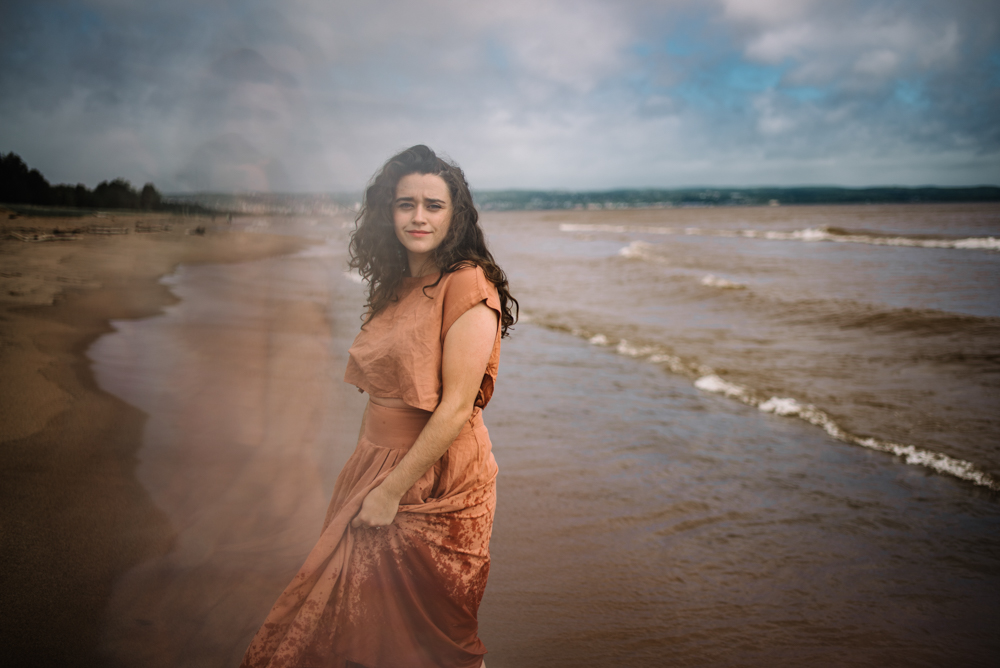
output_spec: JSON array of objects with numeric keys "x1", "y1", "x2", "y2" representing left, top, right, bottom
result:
[{"x1": 243, "y1": 146, "x2": 517, "y2": 668}]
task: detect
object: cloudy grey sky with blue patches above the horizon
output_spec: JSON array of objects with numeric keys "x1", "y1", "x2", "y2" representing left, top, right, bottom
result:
[{"x1": 0, "y1": 0, "x2": 1000, "y2": 192}]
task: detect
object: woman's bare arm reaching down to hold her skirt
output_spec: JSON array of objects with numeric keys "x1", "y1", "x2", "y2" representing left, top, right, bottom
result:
[{"x1": 351, "y1": 302, "x2": 499, "y2": 527}]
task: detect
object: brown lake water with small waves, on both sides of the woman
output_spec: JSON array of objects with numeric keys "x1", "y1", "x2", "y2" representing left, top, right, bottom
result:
[{"x1": 91, "y1": 205, "x2": 1000, "y2": 668}]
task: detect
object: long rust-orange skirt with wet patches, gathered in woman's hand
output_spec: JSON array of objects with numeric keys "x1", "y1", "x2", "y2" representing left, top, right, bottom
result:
[{"x1": 241, "y1": 402, "x2": 497, "y2": 668}]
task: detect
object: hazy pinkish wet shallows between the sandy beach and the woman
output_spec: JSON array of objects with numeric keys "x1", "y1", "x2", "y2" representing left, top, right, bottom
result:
[{"x1": 91, "y1": 253, "x2": 362, "y2": 666}]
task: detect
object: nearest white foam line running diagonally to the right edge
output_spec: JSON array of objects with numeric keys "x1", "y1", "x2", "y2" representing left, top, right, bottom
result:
[{"x1": 572, "y1": 328, "x2": 1000, "y2": 491}]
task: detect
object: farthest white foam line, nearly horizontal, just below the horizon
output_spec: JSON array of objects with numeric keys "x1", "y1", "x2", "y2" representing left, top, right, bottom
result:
[{"x1": 559, "y1": 223, "x2": 1000, "y2": 252}]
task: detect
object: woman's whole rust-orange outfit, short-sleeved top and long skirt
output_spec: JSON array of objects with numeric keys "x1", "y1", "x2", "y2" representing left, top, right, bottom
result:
[{"x1": 242, "y1": 267, "x2": 500, "y2": 668}]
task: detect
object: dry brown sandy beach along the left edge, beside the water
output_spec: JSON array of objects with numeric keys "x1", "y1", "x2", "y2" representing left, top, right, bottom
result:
[{"x1": 0, "y1": 212, "x2": 308, "y2": 666}]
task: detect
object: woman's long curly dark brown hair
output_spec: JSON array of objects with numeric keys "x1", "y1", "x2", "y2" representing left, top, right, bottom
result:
[{"x1": 349, "y1": 144, "x2": 518, "y2": 336}]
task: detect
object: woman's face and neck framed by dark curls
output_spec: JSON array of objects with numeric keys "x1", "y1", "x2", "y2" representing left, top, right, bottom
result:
[{"x1": 392, "y1": 174, "x2": 452, "y2": 276}]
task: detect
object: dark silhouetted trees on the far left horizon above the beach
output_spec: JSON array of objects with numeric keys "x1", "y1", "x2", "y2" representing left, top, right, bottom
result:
[{"x1": 0, "y1": 153, "x2": 164, "y2": 210}]
